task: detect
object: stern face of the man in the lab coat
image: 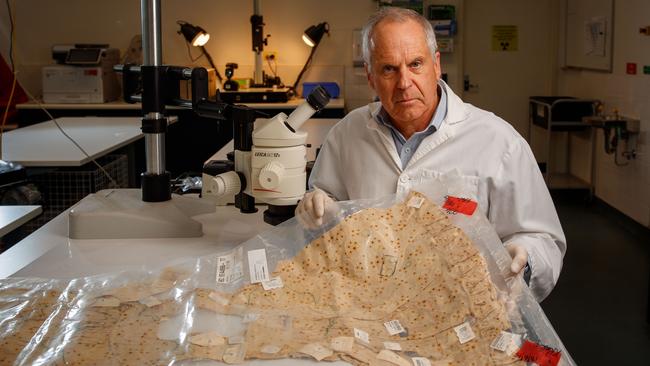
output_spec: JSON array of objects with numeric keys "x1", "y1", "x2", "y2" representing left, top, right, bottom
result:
[{"x1": 366, "y1": 20, "x2": 440, "y2": 130}]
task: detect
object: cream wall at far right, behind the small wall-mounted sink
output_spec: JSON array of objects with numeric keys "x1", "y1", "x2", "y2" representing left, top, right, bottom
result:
[{"x1": 558, "y1": 0, "x2": 650, "y2": 227}]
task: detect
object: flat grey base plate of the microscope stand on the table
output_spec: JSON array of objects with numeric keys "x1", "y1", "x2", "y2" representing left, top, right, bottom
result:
[{"x1": 68, "y1": 189, "x2": 215, "y2": 239}]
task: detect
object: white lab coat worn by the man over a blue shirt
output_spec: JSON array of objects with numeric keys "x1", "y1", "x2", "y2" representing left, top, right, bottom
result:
[{"x1": 309, "y1": 82, "x2": 566, "y2": 301}]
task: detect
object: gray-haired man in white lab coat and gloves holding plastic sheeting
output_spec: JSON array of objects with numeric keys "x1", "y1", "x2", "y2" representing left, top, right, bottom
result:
[{"x1": 296, "y1": 8, "x2": 566, "y2": 301}]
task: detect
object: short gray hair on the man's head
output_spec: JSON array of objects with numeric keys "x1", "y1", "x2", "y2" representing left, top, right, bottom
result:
[{"x1": 361, "y1": 6, "x2": 438, "y2": 70}]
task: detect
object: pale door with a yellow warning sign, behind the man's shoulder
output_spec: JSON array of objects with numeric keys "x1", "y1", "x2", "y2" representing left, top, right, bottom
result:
[{"x1": 460, "y1": 0, "x2": 559, "y2": 137}]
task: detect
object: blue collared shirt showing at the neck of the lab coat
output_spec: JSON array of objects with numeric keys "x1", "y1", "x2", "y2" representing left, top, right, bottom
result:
[{"x1": 375, "y1": 85, "x2": 447, "y2": 169}]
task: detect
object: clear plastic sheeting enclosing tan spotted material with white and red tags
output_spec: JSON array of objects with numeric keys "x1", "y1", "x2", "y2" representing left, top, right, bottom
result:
[{"x1": 0, "y1": 179, "x2": 573, "y2": 366}]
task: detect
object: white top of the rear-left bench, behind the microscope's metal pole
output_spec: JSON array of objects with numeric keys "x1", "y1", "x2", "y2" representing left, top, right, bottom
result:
[{"x1": 2, "y1": 117, "x2": 144, "y2": 167}]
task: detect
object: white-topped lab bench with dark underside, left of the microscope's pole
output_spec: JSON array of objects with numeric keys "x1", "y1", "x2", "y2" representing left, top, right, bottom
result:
[{"x1": 2, "y1": 117, "x2": 144, "y2": 237}]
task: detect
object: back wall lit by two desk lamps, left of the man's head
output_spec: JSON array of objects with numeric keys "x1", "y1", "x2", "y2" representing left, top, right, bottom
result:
[{"x1": 0, "y1": 0, "x2": 378, "y2": 109}]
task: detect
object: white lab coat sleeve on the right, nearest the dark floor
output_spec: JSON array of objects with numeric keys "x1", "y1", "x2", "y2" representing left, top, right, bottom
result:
[{"x1": 488, "y1": 138, "x2": 566, "y2": 301}]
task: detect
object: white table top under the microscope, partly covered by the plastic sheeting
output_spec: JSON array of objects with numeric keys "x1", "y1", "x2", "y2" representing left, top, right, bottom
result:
[{"x1": 0, "y1": 196, "x2": 271, "y2": 278}]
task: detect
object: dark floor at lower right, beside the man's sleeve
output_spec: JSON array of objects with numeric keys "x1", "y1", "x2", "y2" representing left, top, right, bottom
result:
[{"x1": 542, "y1": 194, "x2": 650, "y2": 365}]
